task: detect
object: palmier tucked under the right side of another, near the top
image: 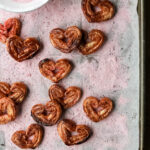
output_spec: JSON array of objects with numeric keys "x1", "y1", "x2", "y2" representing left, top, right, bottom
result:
[{"x1": 78, "y1": 29, "x2": 104, "y2": 55}]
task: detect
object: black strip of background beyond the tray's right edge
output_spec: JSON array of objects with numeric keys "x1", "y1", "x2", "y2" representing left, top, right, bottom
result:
[{"x1": 144, "y1": 0, "x2": 150, "y2": 150}]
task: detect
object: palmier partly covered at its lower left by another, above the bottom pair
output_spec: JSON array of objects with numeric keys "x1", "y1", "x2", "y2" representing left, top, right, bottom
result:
[{"x1": 49, "y1": 84, "x2": 81, "y2": 109}]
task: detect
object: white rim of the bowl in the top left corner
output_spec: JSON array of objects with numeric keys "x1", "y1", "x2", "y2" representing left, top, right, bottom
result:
[{"x1": 0, "y1": 0, "x2": 49, "y2": 13}]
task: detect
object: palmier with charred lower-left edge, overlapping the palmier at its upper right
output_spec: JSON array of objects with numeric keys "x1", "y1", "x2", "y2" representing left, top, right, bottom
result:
[{"x1": 31, "y1": 100, "x2": 62, "y2": 126}]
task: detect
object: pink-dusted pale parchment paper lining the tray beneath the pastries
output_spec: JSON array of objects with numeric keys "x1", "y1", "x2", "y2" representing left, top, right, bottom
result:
[{"x1": 0, "y1": 0, "x2": 139, "y2": 150}]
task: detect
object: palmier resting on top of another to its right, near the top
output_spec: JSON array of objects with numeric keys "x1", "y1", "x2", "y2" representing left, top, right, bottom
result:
[{"x1": 50, "y1": 26, "x2": 82, "y2": 53}]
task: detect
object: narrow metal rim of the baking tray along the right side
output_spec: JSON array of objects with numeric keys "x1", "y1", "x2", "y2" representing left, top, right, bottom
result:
[{"x1": 138, "y1": 0, "x2": 145, "y2": 150}]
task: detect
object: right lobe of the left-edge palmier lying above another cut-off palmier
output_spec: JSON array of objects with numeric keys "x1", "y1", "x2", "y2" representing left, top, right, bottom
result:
[{"x1": 8, "y1": 82, "x2": 27, "y2": 104}]
